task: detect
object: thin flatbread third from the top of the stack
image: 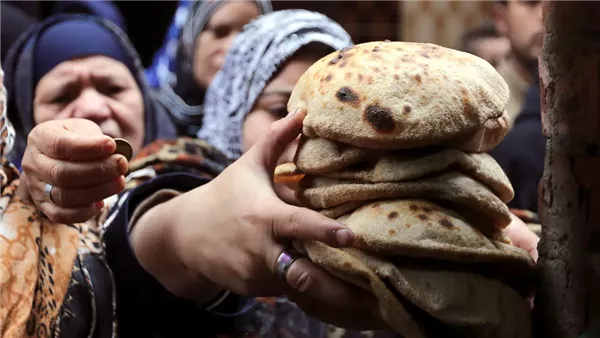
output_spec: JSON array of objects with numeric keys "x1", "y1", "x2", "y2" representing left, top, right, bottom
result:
[{"x1": 296, "y1": 171, "x2": 512, "y2": 229}]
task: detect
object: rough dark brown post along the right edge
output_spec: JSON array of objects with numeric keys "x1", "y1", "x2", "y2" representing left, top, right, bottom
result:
[{"x1": 534, "y1": 0, "x2": 600, "y2": 338}]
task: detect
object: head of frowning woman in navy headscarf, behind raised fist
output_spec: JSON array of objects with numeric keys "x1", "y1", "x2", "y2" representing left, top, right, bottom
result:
[{"x1": 5, "y1": 15, "x2": 175, "y2": 170}]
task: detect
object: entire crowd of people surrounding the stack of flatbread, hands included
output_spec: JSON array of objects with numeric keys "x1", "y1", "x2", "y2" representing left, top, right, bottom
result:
[{"x1": 0, "y1": 0, "x2": 544, "y2": 337}]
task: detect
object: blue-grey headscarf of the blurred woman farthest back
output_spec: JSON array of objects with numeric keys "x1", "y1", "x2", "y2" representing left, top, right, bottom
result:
[{"x1": 157, "y1": 0, "x2": 273, "y2": 132}]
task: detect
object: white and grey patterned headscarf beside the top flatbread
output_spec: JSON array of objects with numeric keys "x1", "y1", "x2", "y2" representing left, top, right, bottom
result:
[{"x1": 198, "y1": 10, "x2": 352, "y2": 159}]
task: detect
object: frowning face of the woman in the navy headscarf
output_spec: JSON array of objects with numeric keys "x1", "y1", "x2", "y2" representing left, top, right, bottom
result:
[{"x1": 33, "y1": 56, "x2": 144, "y2": 152}]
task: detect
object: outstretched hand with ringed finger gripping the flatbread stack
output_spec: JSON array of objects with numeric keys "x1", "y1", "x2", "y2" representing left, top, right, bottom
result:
[{"x1": 150, "y1": 108, "x2": 381, "y2": 327}]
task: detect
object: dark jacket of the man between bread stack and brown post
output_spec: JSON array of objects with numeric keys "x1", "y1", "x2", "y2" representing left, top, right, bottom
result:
[{"x1": 490, "y1": 77, "x2": 546, "y2": 212}]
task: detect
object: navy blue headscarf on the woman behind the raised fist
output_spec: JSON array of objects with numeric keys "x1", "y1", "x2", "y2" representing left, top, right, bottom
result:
[{"x1": 5, "y1": 15, "x2": 176, "y2": 168}]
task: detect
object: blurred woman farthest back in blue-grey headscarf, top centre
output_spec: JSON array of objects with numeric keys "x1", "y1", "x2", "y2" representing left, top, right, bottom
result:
[{"x1": 149, "y1": 0, "x2": 273, "y2": 136}]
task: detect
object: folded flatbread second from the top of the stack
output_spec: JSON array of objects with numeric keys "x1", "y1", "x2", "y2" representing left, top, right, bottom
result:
[{"x1": 285, "y1": 146, "x2": 514, "y2": 203}]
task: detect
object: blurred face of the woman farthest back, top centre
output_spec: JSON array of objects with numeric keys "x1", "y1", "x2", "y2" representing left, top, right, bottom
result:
[{"x1": 194, "y1": 0, "x2": 260, "y2": 89}]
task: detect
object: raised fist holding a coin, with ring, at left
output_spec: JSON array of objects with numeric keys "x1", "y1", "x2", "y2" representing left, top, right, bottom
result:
[{"x1": 18, "y1": 119, "x2": 127, "y2": 223}]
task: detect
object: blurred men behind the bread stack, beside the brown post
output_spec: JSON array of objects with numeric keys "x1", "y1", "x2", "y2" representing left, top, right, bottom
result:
[{"x1": 461, "y1": 0, "x2": 546, "y2": 211}]
